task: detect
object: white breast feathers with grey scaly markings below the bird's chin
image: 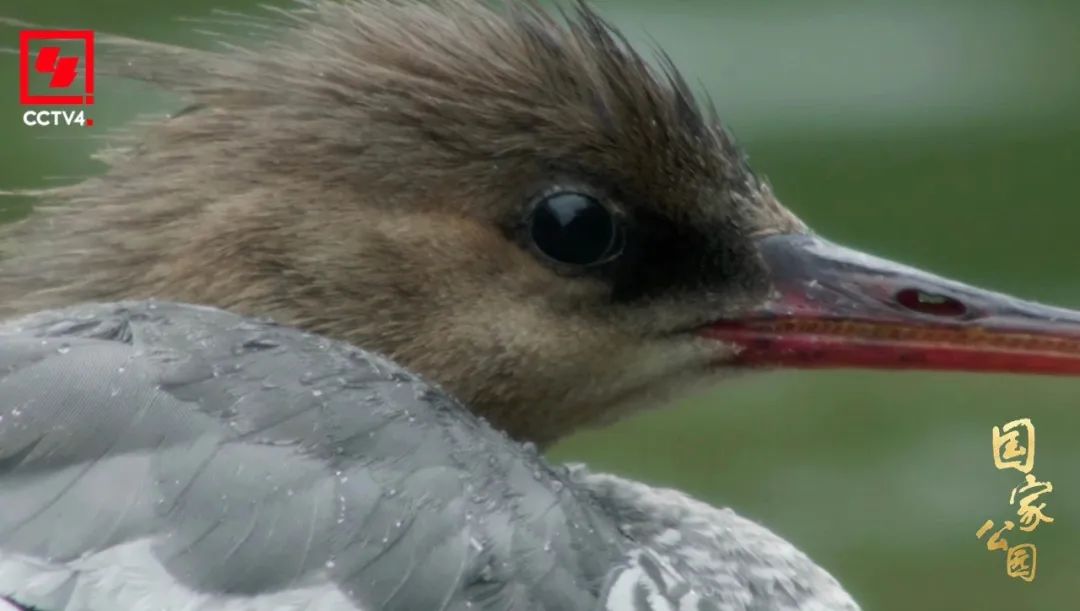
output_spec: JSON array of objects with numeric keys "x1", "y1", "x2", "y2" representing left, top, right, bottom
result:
[{"x1": 570, "y1": 466, "x2": 859, "y2": 611}]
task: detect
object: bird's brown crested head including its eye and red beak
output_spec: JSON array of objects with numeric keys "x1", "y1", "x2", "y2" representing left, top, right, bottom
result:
[{"x1": 8, "y1": 0, "x2": 1080, "y2": 451}]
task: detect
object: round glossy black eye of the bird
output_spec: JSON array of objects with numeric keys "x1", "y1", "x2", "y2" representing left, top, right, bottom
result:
[{"x1": 528, "y1": 192, "x2": 622, "y2": 266}]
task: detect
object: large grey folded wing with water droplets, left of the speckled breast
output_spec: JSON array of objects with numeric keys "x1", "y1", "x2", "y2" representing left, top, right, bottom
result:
[{"x1": 0, "y1": 303, "x2": 626, "y2": 611}]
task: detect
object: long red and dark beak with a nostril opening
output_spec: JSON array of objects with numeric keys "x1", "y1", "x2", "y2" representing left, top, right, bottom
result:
[{"x1": 703, "y1": 235, "x2": 1080, "y2": 376}]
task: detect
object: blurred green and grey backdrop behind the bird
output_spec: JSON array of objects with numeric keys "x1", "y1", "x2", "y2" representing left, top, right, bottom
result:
[{"x1": 0, "y1": 0, "x2": 1080, "y2": 611}]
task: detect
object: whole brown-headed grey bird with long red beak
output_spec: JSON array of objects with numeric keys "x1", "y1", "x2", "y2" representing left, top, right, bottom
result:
[{"x1": 0, "y1": 0, "x2": 1080, "y2": 611}]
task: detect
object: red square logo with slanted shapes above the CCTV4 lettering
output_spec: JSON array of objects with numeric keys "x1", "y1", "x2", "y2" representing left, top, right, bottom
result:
[{"x1": 18, "y1": 30, "x2": 94, "y2": 106}]
